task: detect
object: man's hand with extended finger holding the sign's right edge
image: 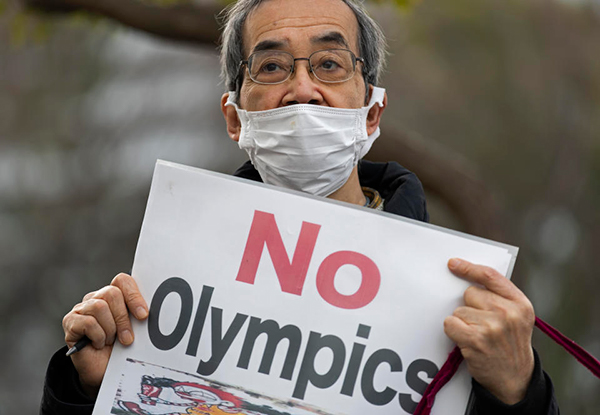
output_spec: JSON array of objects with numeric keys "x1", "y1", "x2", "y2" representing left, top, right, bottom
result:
[{"x1": 444, "y1": 259, "x2": 535, "y2": 405}]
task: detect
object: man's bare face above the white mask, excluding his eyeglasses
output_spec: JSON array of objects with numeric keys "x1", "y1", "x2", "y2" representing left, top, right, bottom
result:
[{"x1": 239, "y1": 0, "x2": 365, "y2": 111}]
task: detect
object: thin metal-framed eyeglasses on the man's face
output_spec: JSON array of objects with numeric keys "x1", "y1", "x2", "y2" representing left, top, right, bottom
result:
[{"x1": 240, "y1": 49, "x2": 365, "y2": 85}]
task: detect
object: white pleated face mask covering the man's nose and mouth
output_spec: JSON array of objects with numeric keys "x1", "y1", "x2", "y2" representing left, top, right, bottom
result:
[{"x1": 225, "y1": 88, "x2": 385, "y2": 196}]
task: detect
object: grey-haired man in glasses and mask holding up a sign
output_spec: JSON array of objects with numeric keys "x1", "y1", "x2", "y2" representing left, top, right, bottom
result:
[{"x1": 41, "y1": 0, "x2": 558, "y2": 415}]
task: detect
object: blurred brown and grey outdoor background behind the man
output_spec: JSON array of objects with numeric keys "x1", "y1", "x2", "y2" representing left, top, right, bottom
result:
[{"x1": 0, "y1": 0, "x2": 600, "y2": 415}]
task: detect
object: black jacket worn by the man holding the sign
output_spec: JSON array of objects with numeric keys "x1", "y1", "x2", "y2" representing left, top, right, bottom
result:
[{"x1": 40, "y1": 160, "x2": 559, "y2": 415}]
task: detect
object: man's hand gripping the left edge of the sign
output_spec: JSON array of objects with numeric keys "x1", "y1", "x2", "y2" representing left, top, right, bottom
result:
[{"x1": 63, "y1": 273, "x2": 148, "y2": 397}]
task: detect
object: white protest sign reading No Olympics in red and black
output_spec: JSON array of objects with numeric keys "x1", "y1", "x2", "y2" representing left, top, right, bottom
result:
[{"x1": 94, "y1": 161, "x2": 516, "y2": 415}]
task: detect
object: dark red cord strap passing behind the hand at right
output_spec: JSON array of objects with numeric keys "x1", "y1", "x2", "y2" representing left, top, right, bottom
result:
[{"x1": 413, "y1": 317, "x2": 600, "y2": 415}]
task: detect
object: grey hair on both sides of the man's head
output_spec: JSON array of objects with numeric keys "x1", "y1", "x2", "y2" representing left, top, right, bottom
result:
[{"x1": 221, "y1": 0, "x2": 386, "y2": 96}]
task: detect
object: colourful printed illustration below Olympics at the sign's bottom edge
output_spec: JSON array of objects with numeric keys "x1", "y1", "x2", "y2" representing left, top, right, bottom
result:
[{"x1": 111, "y1": 359, "x2": 325, "y2": 415}]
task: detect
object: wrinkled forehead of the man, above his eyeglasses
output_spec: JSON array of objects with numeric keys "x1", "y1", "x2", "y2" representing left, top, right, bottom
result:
[{"x1": 243, "y1": 0, "x2": 358, "y2": 56}]
